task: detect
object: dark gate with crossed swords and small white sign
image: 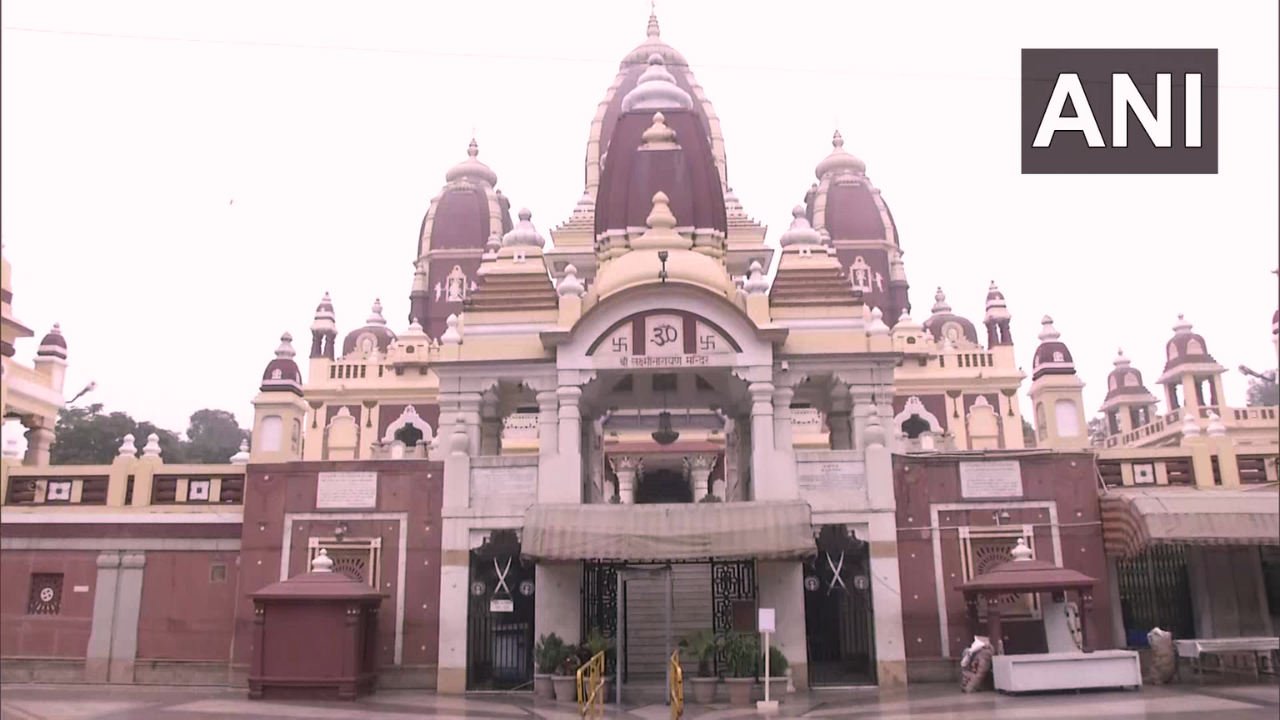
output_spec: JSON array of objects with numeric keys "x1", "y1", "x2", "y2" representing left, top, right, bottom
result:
[{"x1": 467, "y1": 530, "x2": 535, "y2": 691}]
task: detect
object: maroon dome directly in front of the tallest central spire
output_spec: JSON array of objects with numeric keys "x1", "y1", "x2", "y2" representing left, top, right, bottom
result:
[{"x1": 595, "y1": 110, "x2": 728, "y2": 237}]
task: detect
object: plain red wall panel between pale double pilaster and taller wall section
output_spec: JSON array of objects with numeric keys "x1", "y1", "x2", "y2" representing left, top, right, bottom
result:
[{"x1": 138, "y1": 551, "x2": 239, "y2": 662}]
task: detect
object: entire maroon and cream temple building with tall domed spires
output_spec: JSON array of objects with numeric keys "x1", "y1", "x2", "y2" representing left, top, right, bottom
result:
[{"x1": 0, "y1": 9, "x2": 1280, "y2": 693}]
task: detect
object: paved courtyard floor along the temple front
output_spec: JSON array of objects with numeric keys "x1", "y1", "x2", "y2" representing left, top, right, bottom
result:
[{"x1": 0, "y1": 683, "x2": 1280, "y2": 720}]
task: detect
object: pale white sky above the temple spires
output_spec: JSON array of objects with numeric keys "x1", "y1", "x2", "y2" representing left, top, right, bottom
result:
[{"x1": 0, "y1": 0, "x2": 1280, "y2": 443}]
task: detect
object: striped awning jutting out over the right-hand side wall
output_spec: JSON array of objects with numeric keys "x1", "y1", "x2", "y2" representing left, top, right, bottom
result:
[{"x1": 1100, "y1": 488, "x2": 1280, "y2": 557}]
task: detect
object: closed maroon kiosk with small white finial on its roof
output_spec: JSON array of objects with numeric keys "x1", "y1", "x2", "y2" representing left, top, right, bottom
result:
[{"x1": 248, "y1": 550, "x2": 385, "y2": 700}]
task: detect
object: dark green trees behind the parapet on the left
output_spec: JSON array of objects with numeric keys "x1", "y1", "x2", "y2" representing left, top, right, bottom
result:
[{"x1": 49, "y1": 402, "x2": 183, "y2": 465}]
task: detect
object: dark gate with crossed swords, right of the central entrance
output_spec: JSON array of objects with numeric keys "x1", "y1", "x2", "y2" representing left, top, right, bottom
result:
[{"x1": 804, "y1": 525, "x2": 876, "y2": 687}]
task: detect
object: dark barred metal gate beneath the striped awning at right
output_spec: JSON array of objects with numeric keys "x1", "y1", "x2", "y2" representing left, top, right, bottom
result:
[{"x1": 1116, "y1": 544, "x2": 1196, "y2": 647}]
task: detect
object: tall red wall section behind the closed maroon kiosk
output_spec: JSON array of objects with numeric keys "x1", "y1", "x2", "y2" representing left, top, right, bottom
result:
[{"x1": 233, "y1": 460, "x2": 444, "y2": 667}]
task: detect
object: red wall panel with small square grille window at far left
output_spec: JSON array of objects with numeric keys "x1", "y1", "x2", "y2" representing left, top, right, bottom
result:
[{"x1": 0, "y1": 550, "x2": 97, "y2": 659}]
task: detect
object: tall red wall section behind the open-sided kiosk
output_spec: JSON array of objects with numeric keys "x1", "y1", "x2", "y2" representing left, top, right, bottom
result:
[{"x1": 893, "y1": 454, "x2": 1112, "y2": 660}]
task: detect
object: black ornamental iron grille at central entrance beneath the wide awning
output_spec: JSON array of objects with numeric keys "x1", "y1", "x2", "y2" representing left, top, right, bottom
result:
[{"x1": 582, "y1": 560, "x2": 756, "y2": 679}]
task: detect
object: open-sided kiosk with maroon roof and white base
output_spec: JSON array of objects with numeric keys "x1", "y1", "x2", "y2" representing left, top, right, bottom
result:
[{"x1": 956, "y1": 538, "x2": 1142, "y2": 693}]
